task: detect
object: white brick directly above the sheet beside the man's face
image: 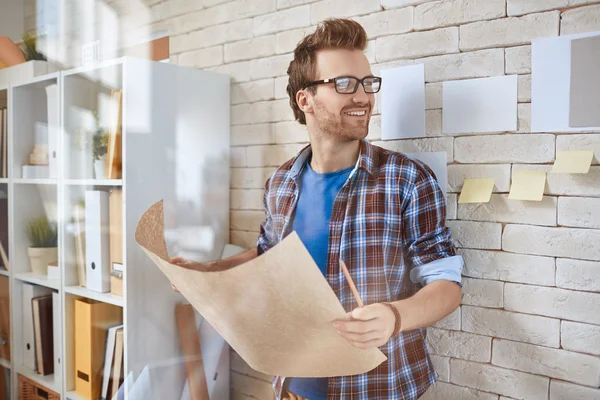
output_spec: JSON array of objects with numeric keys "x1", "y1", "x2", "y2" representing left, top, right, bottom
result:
[{"x1": 375, "y1": 27, "x2": 458, "y2": 62}]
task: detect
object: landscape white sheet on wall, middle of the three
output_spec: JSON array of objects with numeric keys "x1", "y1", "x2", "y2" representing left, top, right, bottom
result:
[{"x1": 442, "y1": 75, "x2": 517, "y2": 134}]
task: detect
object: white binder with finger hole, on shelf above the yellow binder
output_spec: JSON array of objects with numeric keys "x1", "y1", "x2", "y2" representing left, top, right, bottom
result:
[{"x1": 85, "y1": 190, "x2": 110, "y2": 293}]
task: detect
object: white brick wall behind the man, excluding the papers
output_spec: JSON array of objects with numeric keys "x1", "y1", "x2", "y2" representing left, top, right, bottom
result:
[{"x1": 124, "y1": 0, "x2": 600, "y2": 400}]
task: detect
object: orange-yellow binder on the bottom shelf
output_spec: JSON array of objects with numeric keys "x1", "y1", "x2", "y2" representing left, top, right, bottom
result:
[{"x1": 75, "y1": 299, "x2": 123, "y2": 400}]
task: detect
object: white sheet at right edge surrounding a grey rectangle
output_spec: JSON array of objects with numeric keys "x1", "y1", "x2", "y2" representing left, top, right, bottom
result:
[{"x1": 531, "y1": 32, "x2": 600, "y2": 132}]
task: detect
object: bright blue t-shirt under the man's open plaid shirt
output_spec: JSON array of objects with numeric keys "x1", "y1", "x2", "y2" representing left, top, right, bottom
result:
[{"x1": 286, "y1": 161, "x2": 354, "y2": 400}]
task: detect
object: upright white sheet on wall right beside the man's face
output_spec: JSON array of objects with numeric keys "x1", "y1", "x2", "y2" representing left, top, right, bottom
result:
[{"x1": 381, "y1": 64, "x2": 426, "y2": 140}]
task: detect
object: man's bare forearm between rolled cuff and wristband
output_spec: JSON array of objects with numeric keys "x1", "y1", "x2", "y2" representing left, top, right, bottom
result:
[{"x1": 392, "y1": 280, "x2": 462, "y2": 331}]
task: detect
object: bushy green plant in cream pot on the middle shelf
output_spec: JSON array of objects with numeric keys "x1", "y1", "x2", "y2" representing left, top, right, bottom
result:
[{"x1": 27, "y1": 215, "x2": 58, "y2": 275}]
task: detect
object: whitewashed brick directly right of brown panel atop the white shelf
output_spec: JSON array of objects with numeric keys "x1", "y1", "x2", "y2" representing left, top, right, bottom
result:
[{"x1": 170, "y1": 19, "x2": 253, "y2": 54}]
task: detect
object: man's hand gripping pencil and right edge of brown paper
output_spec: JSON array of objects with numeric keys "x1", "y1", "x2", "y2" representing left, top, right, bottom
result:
[{"x1": 332, "y1": 303, "x2": 396, "y2": 349}]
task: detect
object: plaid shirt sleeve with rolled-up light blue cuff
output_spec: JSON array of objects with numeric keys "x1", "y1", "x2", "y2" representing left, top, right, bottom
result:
[{"x1": 402, "y1": 162, "x2": 464, "y2": 285}]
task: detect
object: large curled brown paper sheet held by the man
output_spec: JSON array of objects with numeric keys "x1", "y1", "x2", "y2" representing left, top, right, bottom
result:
[{"x1": 135, "y1": 200, "x2": 386, "y2": 377}]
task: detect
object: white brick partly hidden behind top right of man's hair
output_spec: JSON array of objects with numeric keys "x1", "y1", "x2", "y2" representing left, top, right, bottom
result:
[{"x1": 355, "y1": 7, "x2": 414, "y2": 39}]
